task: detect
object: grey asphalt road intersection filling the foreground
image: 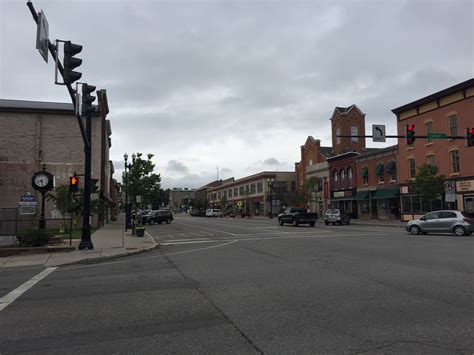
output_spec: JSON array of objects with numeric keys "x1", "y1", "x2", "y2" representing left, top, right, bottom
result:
[{"x1": 0, "y1": 217, "x2": 474, "y2": 355}]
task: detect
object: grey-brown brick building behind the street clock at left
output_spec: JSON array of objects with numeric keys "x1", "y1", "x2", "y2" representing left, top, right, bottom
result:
[{"x1": 0, "y1": 94, "x2": 114, "y2": 231}]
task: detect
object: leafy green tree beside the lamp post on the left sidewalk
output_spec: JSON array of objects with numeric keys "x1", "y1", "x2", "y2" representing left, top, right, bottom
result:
[{"x1": 124, "y1": 153, "x2": 161, "y2": 210}]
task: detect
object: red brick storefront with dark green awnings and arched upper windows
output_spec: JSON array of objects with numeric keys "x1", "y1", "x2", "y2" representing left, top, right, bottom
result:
[{"x1": 354, "y1": 145, "x2": 400, "y2": 219}]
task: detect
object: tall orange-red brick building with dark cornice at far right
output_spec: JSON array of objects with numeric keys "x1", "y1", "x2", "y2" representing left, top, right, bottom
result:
[{"x1": 392, "y1": 79, "x2": 474, "y2": 220}]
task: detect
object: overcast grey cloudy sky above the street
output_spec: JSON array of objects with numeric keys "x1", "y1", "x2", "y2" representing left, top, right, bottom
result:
[{"x1": 0, "y1": 0, "x2": 474, "y2": 188}]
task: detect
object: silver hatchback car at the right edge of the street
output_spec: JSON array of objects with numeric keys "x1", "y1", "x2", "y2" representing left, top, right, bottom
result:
[{"x1": 405, "y1": 210, "x2": 474, "y2": 236}]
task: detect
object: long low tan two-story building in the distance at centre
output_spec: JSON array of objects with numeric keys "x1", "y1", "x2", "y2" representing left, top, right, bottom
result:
[{"x1": 207, "y1": 171, "x2": 296, "y2": 216}]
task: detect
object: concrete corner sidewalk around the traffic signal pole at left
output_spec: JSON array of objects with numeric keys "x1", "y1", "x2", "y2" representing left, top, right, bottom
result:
[{"x1": 0, "y1": 214, "x2": 158, "y2": 268}]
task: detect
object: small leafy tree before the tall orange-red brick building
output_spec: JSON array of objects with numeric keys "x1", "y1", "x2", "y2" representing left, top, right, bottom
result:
[{"x1": 409, "y1": 164, "x2": 445, "y2": 210}]
